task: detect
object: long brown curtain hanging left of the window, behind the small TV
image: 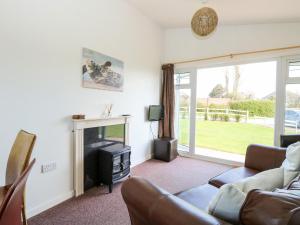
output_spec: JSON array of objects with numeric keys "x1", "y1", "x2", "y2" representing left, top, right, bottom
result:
[{"x1": 159, "y1": 64, "x2": 175, "y2": 138}]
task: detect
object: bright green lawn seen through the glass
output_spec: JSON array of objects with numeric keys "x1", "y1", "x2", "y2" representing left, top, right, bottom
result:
[{"x1": 179, "y1": 119, "x2": 274, "y2": 154}]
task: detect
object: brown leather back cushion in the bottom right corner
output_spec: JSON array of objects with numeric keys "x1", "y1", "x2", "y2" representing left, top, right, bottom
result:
[{"x1": 240, "y1": 190, "x2": 300, "y2": 225}]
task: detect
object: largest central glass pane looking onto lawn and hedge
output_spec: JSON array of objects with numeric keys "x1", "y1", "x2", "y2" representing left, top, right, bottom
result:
[{"x1": 195, "y1": 61, "x2": 277, "y2": 159}]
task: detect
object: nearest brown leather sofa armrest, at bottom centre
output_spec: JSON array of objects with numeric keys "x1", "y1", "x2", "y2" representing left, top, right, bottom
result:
[{"x1": 121, "y1": 177, "x2": 225, "y2": 225}]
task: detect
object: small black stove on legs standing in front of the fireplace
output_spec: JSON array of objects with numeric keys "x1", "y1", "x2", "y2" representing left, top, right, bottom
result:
[{"x1": 98, "y1": 143, "x2": 131, "y2": 193}]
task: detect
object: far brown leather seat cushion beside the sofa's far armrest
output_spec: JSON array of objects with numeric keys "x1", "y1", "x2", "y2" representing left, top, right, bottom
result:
[{"x1": 209, "y1": 167, "x2": 260, "y2": 188}]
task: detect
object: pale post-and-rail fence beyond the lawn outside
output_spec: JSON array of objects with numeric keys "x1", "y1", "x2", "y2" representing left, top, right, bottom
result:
[{"x1": 179, "y1": 107, "x2": 249, "y2": 122}]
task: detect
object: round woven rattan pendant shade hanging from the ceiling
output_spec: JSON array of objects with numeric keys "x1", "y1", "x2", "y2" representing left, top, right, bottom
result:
[{"x1": 191, "y1": 7, "x2": 218, "y2": 36}]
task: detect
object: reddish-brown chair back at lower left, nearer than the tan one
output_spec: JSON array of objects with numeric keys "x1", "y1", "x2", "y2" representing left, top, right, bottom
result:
[{"x1": 0, "y1": 159, "x2": 35, "y2": 225}]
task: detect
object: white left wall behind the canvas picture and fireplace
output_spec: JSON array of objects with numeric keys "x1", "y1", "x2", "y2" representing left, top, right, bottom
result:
[{"x1": 0, "y1": 0, "x2": 163, "y2": 215}]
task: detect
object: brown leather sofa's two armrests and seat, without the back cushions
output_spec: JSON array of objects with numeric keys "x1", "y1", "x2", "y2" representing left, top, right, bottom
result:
[{"x1": 122, "y1": 142, "x2": 300, "y2": 225}]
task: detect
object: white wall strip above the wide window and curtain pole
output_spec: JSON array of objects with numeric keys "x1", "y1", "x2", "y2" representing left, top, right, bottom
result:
[{"x1": 164, "y1": 23, "x2": 300, "y2": 62}]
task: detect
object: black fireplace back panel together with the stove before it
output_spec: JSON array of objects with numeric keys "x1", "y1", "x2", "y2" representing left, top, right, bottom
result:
[{"x1": 84, "y1": 124, "x2": 131, "y2": 193}]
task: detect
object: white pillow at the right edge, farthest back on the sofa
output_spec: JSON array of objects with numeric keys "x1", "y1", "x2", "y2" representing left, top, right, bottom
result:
[{"x1": 282, "y1": 142, "x2": 300, "y2": 171}]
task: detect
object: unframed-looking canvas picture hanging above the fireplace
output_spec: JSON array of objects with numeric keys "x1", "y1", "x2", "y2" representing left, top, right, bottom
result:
[{"x1": 82, "y1": 48, "x2": 124, "y2": 91}]
